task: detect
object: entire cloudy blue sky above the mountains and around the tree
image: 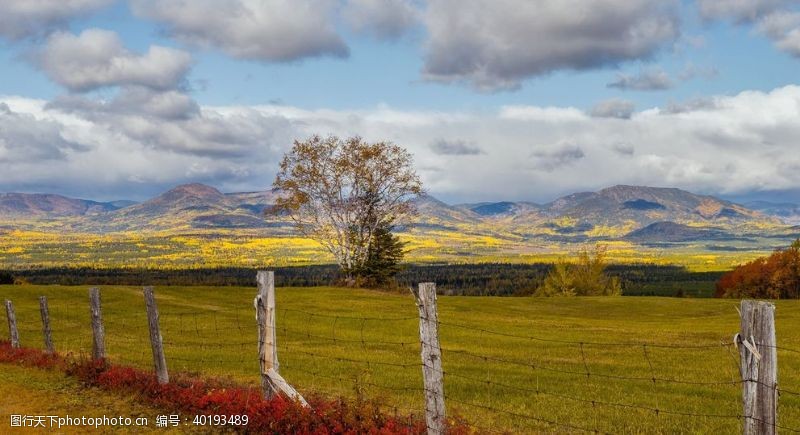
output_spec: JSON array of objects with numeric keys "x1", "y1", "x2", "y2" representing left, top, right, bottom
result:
[{"x1": 0, "y1": 0, "x2": 800, "y2": 203}]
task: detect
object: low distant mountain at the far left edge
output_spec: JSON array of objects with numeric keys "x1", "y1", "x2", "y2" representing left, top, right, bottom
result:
[{"x1": 0, "y1": 193, "x2": 119, "y2": 218}]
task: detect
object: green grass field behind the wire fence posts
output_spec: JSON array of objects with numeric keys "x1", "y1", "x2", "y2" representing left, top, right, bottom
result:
[{"x1": 0, "y1": 286, "x2": 800, "y2": 433}]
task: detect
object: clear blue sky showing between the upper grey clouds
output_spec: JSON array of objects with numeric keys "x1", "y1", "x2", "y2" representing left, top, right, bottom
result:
[{"x1": 0, "y1": 1, "x2": 798, "y2": 111}]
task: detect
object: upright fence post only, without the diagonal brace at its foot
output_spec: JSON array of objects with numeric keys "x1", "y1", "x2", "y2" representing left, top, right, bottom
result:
[{"x1": 256, "y1": 271, "x2": 280, "y2": 397}]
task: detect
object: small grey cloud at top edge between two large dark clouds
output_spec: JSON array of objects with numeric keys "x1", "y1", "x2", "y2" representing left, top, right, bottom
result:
[{"x1": 342, "y1": 0, "x2": 419, "y2": 39}]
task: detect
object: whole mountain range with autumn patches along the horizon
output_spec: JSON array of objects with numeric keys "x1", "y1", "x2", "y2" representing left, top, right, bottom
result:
[{"x1": 0, "y1": 183, "x2": 798, "y2": 243}]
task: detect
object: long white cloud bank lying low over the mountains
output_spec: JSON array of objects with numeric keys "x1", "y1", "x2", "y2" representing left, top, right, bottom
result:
[{"x1": 0, "y1": 86, "x2": 800, "y2": 202}]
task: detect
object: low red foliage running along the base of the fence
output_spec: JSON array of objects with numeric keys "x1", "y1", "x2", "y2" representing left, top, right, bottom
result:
[{"x1": 0, "y1": 341, "x2": 472, "y2": 435}]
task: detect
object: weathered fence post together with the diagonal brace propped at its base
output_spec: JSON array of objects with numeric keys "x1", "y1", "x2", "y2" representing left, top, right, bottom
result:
[{"x1": 253, "y1": 271, "x2": 308, "y2": 406}]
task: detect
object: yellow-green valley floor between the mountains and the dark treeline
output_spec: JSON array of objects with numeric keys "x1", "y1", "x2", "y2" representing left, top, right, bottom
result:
[{"x1": 0, "y1": 226, "x2": 776, "y2": 272}]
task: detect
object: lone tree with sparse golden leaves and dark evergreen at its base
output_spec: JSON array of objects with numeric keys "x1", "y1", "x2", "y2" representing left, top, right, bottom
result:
[{"x1": 272, "y1": 136, "x2": 423, "y2": 285}]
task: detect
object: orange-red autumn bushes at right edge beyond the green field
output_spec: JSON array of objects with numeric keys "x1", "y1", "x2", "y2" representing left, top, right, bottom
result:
[{"x1": 714, "y1": 239, "x2": 800, "y2": 299}]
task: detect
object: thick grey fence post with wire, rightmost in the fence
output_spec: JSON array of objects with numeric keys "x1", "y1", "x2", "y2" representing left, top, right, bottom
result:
[{"x1": 736, "y1": 301, "x2": 778, "y2": 435}]
